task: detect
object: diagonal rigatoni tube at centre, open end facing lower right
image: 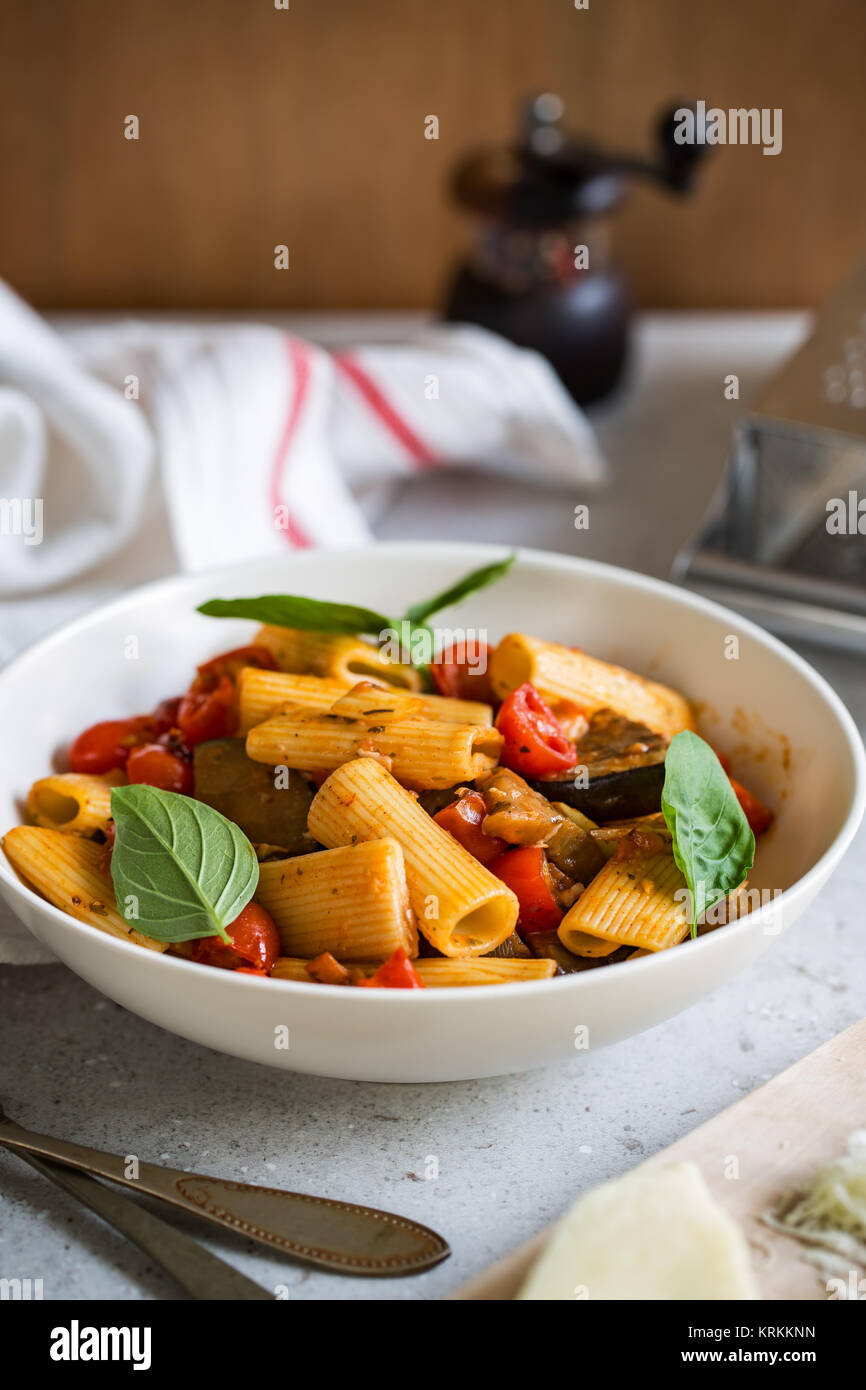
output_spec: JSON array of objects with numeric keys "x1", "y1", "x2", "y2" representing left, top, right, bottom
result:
[{"x1": 309, "y1": 758, "x2": 518, "y2": 958}]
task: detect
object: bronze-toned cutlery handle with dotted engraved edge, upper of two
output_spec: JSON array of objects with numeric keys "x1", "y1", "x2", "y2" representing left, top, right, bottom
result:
[{"x1": 0, "y1": 1106, "x2": 450, "y2": 1277}]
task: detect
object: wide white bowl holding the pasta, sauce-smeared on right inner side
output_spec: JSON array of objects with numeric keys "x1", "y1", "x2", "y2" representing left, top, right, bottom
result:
[{"x1": 0, "y1": 542, "x2": 866, "y2": 1081}]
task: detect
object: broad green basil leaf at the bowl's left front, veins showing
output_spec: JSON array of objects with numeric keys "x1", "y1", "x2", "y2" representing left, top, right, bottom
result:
[{"x1": 111, "y1": 783, "x2": 259, "y2": 941}]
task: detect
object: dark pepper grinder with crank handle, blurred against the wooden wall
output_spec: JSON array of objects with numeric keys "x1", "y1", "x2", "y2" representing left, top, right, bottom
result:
[{"x1": 443, "y1": 93, "x2": 706, "y2": 404}]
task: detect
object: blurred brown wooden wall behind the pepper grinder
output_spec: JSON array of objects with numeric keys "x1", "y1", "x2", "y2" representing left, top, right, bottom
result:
[{"x1": 0, "y1": 0, "x2": 866, "y2": 309}]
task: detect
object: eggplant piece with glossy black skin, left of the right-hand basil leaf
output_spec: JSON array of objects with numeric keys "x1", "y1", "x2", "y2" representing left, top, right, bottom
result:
[{"x1": 530, "y1": 709, "x2": 667, "y2": 821}]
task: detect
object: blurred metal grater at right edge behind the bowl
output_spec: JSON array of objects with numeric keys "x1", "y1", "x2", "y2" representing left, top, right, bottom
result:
[{"x1": 673, "y1": 263, "x2": 866, "y2": 652}]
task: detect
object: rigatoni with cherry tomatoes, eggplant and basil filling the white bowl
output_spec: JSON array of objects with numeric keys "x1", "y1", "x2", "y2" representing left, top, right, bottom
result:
[{"x1": 3, "y1": 560, "x2": 773, "y2": 990}]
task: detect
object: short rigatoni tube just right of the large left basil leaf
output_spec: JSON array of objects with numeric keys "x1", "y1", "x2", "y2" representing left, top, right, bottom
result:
[{"x1": 256, "y1": 840, "x2": 418, "y2": 960}]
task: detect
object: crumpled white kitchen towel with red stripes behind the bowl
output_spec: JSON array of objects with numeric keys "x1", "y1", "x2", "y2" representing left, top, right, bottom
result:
[{"x1": 0, "y1": 286, "x2": 605, "y2": 596}]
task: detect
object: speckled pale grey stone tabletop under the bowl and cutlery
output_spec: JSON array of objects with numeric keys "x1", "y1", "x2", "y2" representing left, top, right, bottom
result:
[{"x1": 0, "y1": 316, "x2": 866, "y2": 1300}]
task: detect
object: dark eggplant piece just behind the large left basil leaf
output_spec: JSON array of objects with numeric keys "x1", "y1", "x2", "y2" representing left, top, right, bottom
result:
[{"x1": 195, "y1": 738, "x2": 318, "y2": 855}]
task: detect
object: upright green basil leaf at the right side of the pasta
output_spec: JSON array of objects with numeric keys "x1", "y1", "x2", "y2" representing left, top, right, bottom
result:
[{"x1": 662, "y1": 730, "x2": 755, "y2": 937}]
